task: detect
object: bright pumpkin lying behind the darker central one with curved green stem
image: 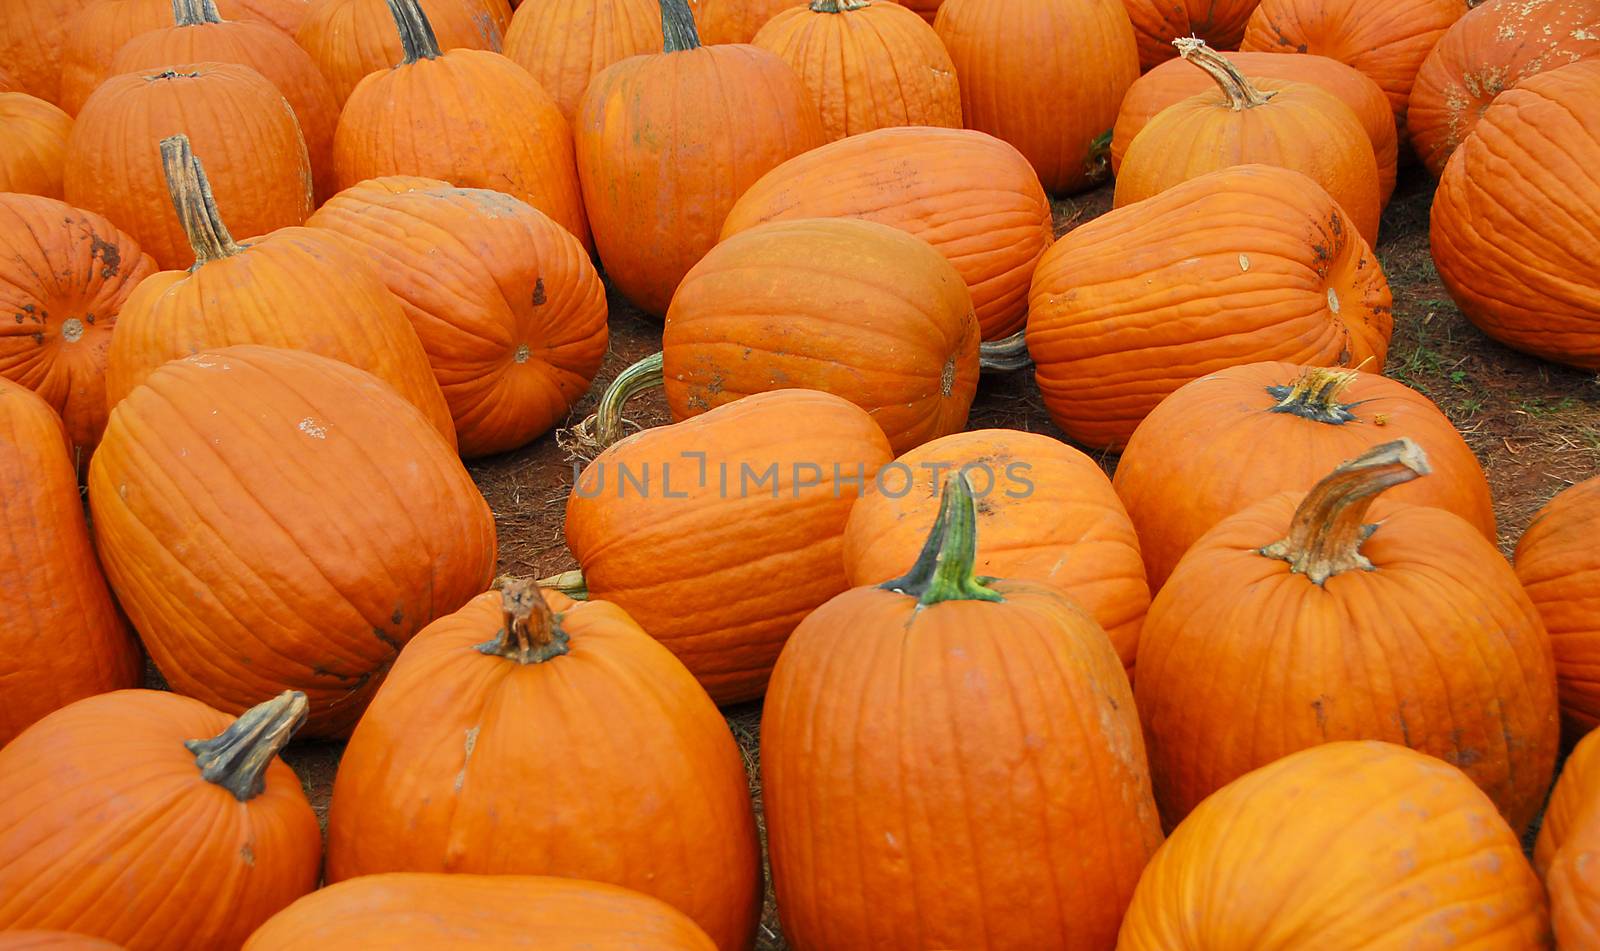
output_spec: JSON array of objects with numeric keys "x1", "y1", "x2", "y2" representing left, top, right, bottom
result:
[{"x1": 722, "y1": 128, "x2": 1054, "y2": 339}]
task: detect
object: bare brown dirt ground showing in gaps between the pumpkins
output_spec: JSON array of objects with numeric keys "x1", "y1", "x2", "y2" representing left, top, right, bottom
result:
[{"x1": 243, "y1": 167, "x2": 1600, "y2": 949}]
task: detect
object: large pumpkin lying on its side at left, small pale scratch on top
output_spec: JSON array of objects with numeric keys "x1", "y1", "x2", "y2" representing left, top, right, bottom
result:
[{"x1": 88, "y1": 346, "x2": 494, "y2": 736}]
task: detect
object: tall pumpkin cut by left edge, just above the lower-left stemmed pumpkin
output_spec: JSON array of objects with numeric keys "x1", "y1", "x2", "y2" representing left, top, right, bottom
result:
[{"x1": 0, "y1": 378, "x2": 144, "y2": 746}]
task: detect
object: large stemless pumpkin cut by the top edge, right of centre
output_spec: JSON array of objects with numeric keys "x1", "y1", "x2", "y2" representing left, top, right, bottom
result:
[{"x1": 933, "y1": 0, "x2": 1139, "y2": 194}]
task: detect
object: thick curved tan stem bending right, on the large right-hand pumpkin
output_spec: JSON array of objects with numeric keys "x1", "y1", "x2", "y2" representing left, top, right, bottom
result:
[{"x1": 1261, "y1": 439, "x2": 1432, "y2": 584}]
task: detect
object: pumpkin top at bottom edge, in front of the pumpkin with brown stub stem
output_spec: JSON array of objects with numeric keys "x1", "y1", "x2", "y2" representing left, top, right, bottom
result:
[{"x1": 241, "y1": 873, "x2": 717, "y2": 951}]
